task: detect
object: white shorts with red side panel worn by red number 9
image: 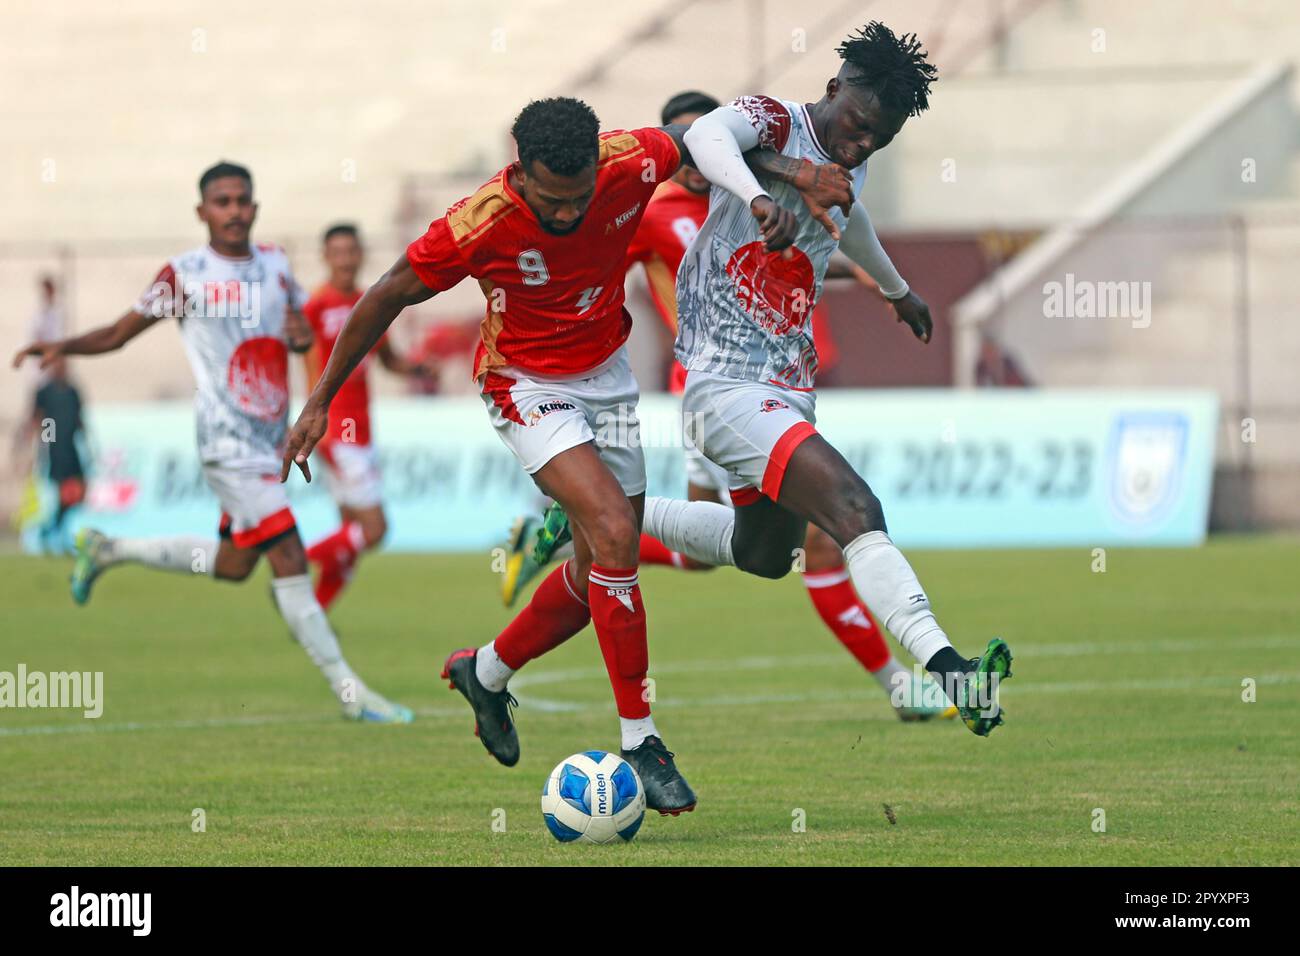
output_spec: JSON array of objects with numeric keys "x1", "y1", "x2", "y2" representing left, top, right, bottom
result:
[{"x1": 481, "y1": 349, "x2": 646, "y2": 497}]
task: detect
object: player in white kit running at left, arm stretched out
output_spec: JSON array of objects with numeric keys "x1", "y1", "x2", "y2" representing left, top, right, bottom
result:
[{"x1": 14, "y1": 163, "x2": 412, "y2": 723}]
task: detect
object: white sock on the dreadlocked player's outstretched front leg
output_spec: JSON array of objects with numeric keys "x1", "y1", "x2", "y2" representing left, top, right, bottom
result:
[{"x1": 844, "y1": 531, "x2": 952, "y2": 665}]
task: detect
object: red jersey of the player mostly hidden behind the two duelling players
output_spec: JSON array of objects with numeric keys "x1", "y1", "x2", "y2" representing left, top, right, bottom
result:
[{"x1": 628, "y1": 181, "x2": 840, "y2": 394}]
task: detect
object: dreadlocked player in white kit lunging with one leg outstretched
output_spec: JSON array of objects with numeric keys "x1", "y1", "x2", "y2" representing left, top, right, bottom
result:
[{"x1": 645, "y1": 22, "x2": 1011, "y2": 736}]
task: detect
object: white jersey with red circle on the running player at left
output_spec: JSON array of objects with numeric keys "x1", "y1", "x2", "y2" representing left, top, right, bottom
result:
[{"x1": 135, "y1": 243, "x2": 307, "y2": 471}]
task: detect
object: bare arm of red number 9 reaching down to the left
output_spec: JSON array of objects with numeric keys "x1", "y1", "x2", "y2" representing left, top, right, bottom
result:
[{"x1": 280, "y1": 255, "x2": 433, "y2": 481}]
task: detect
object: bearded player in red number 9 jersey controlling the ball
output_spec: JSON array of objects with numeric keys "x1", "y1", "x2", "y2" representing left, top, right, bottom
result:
[{"x1": 281, "y1": 98, "x2": 848, "y2": 814}]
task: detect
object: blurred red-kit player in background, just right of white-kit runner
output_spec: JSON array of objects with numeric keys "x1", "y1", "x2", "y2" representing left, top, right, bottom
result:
[{"x1": 303, "y1": 222, "x2": 425, "y2": 609}]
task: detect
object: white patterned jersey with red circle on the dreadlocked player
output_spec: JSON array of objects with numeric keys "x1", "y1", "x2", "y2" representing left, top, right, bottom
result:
[{"x1": 676, "y1": 96, "x2": 867, "y2": 389}]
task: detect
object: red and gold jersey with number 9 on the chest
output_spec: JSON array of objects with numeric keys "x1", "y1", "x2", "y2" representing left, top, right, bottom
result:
[{"x1": 407, "y1": 127, "x2": 681, "y2": 378}]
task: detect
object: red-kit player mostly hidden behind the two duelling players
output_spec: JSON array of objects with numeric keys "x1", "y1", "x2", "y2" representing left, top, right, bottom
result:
[{"x1": 512, "y1": 91, "x2": 957, "y2": 721}]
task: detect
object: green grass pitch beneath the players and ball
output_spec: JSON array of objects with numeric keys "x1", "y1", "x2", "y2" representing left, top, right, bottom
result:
[{"x1": 0, "y1": 537, "x2": 1300, "y2": 865}]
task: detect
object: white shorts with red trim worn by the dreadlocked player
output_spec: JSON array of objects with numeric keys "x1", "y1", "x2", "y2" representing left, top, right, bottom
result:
[{"x1": 681, "y1": 372, "x2": 816, "y2": 505}]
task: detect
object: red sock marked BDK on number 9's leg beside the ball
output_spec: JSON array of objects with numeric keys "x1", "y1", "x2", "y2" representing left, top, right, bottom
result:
[{"x1": 586, "y1": 564, "x2": 650, "y2": 718}]
